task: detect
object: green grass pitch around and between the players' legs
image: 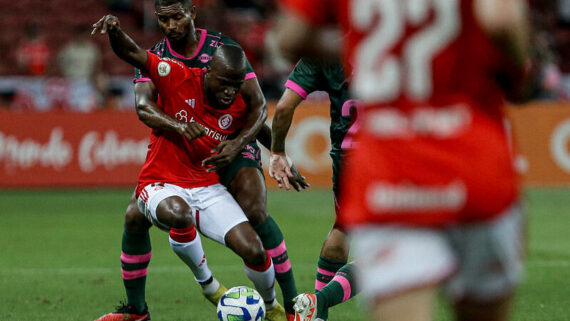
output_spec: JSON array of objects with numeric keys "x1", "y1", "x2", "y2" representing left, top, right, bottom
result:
[{"x1": 0, "y1": 189, "x2": 570, "y2": 321}]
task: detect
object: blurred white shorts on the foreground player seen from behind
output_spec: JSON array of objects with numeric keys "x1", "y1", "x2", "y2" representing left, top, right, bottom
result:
[{"x1": 350, "y1": 205, "x2": 523, "y2": 302}]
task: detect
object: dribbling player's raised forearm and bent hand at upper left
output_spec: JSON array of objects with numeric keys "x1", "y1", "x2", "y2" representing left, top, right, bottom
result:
[{"x1": 91, "y1": 15, "x2": 147, "y2": 71}]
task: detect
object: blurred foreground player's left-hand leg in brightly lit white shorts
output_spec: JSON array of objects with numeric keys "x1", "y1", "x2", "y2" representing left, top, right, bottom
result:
[{"x1": 351, "y1": 226, "x2": 457, "y2": 321}]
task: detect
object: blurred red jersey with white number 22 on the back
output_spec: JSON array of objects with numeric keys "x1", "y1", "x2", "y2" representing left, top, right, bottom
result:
[{"x1": 285, "y1": 0, "x2": 518, "y2": 226}]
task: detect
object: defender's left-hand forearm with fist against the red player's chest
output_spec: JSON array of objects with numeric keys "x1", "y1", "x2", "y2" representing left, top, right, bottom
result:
[{"x1": 135, "y1": 81, "x2": 206, "y2": 140}]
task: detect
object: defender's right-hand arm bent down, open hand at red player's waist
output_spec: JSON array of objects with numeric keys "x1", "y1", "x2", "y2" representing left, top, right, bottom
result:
[{"x1": 202, "y1": 77, "x2": 267, "y2": 172}]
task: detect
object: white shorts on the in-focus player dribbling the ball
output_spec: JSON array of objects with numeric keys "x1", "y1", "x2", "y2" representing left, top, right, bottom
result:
[{"x1": 137, "y1": 184, "x2": 247, "y2": 245}]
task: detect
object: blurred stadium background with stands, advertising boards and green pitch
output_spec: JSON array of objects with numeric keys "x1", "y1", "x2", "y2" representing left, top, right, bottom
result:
[{"x1": 0, "y1": 0, "x2": 570, "y2": 321}]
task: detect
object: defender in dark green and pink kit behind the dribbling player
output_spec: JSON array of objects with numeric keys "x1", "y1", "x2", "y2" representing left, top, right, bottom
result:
[{"x1": 100, "y1": 0, "x2": 305, "y2": 317}]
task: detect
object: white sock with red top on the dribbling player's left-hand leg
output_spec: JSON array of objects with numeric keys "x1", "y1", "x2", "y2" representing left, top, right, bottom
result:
[{"x1": 168, "y1": 234, "x2": 213, "y2": 282}]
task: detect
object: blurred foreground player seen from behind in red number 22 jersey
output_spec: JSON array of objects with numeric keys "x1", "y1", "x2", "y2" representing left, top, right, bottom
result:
[{"x1": 279, "y1": 0, "x2": 529, "y2": 321}]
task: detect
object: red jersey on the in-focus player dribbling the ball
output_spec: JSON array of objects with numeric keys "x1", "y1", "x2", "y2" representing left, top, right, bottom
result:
[{"x1": 137, "y1": 52, "x2": 246, "y2": 196}]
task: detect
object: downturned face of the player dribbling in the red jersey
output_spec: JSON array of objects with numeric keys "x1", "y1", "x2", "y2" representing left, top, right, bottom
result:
[{"x1": 204, "y1": 68, "x2": 245, "y2": 109}]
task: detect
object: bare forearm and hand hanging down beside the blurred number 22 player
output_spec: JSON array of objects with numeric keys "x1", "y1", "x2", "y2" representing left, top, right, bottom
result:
[{"x1": 269, "y1": 88, "x2": 303, "y2": 190}]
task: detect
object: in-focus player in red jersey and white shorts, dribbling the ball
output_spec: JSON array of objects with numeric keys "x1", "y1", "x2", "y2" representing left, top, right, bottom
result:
[{"x1": 93, "y1": 15, "x2": 286, "y2": 321}]
